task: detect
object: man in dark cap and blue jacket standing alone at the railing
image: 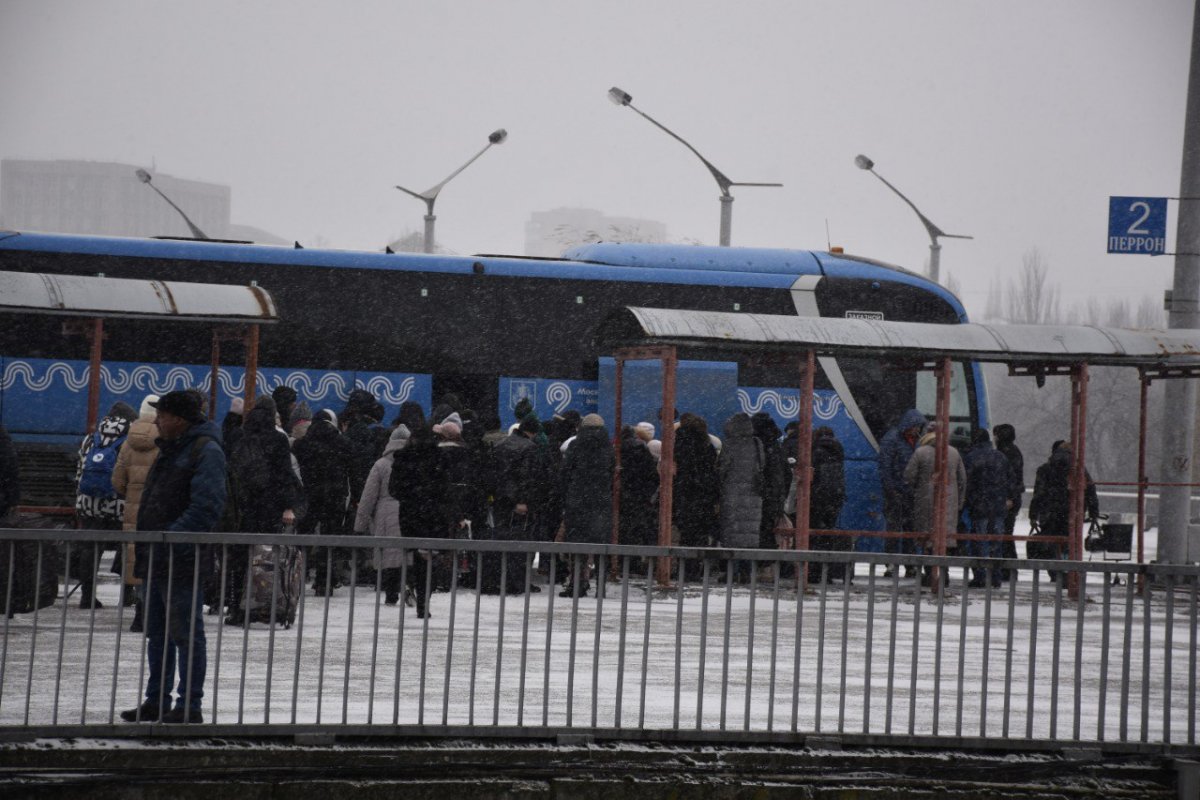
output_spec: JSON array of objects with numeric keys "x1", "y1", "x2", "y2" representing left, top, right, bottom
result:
[{"x1": 121, "y1": 389, "x2": 226, "y2": 722}]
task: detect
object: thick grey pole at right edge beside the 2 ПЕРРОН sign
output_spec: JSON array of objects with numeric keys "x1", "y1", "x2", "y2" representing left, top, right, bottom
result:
[{"x1": 1158, "y1": 0, "x2": 1200, "y2": 564}]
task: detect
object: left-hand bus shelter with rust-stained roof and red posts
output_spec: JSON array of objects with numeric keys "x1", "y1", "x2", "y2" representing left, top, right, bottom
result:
[{"x1": 0, "y1": 271, "x2": 278, "y2": 431}]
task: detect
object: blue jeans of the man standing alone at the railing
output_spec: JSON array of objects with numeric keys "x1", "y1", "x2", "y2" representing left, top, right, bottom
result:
[{"x1": 145, "y1": 571, "x2": 208, "y2": 711}]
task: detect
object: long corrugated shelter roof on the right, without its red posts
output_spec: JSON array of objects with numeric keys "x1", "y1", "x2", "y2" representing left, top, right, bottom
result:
[{"x1": 596, "y1": 306, "x2": 1200, "y2": 368}]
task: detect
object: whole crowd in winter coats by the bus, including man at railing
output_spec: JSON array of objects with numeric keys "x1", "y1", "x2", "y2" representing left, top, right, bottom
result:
[{"x1": 0, "y1": 386, "x2": 1097, "y2": 722}]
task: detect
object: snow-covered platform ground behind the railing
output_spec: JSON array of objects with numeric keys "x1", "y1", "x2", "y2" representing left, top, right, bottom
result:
[{"x1": 0, "y1": 525, "x2": 1196, "y2": 744}]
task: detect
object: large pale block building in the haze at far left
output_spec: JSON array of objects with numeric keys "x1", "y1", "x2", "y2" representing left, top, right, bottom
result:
[{"x1": 0, "y1": 158, "x2": 287, "y2": 243}]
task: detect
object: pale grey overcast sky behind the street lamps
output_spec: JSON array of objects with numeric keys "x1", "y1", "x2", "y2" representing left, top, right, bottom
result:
[{"x1": 0, "y1": 0, "x2": 1193, "y2": 313}]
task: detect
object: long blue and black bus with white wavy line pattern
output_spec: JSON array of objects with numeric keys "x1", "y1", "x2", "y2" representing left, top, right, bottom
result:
[{"x1": 0, "y1": 231, "x2": 988, "y2": 544}]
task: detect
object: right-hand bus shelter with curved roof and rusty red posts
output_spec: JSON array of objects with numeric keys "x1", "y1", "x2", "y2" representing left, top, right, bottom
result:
[{"x1": 596, "y1": 307, "x2": 1200, "y2": 597}]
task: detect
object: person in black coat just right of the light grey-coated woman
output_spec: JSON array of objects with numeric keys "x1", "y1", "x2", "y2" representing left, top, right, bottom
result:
[{"x1": 388, "y1": 425, "x2": 448, "y2": 618}]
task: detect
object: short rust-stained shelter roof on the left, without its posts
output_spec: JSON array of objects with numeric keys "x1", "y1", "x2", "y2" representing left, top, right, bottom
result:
[{"x1": 0, "y1": 271, "x2": 278, "y2": 323}]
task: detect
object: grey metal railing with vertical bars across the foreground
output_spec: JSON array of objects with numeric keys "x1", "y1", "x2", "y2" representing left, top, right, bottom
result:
[{"x1": 0, "y1": 529, "x2": 1200, "y2": 752}]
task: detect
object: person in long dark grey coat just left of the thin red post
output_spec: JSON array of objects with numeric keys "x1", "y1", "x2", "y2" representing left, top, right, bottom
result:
[{"x1": 560, "y1": 414, "x2": 616, "y2": 597}]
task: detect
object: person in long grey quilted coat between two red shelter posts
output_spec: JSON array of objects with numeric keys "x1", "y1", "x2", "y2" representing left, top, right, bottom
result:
[{"x1": 716, "y1": 413, "x2": 766, "y2": 575}]
